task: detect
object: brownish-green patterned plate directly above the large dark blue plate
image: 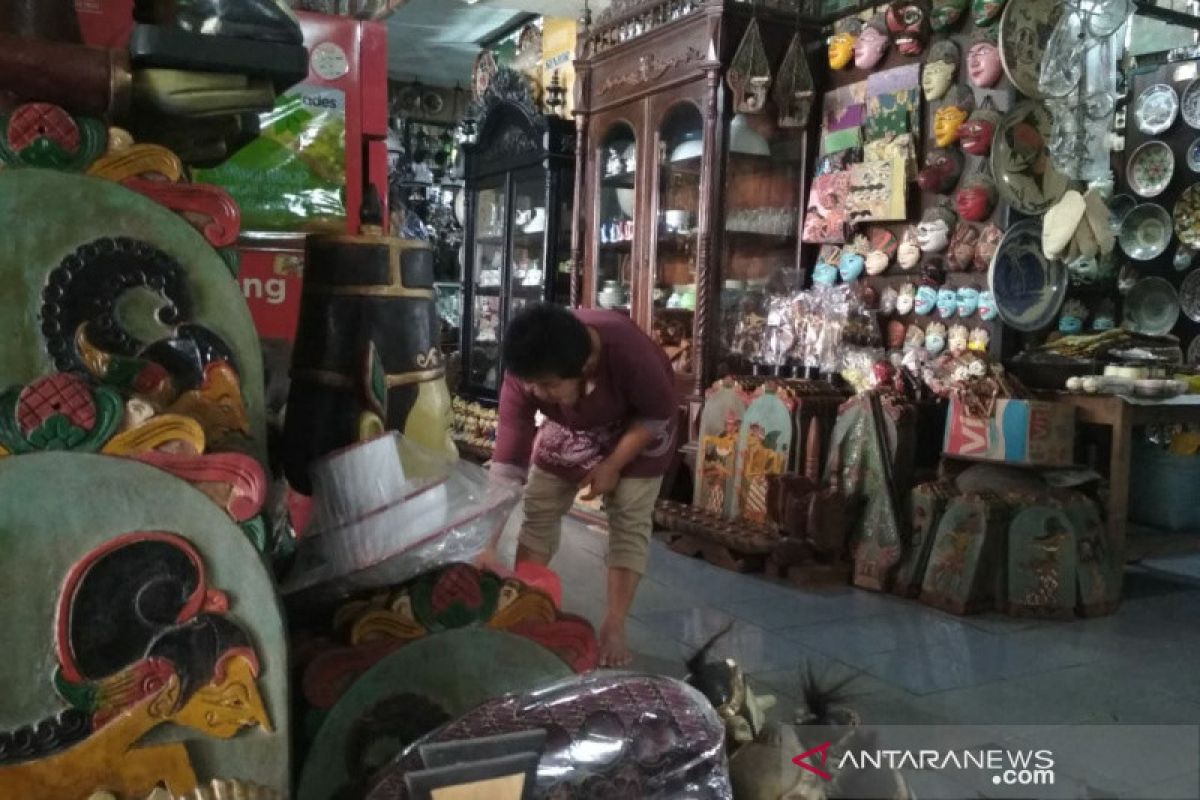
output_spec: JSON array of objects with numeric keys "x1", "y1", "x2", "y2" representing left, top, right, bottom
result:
[{"x1": 991, "y1": 100, "x2": 1068, "y2": 217}]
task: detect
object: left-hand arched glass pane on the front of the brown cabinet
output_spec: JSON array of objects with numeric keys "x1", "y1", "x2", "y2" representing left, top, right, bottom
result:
[{"x1": 593, "y1": 122, "x2": 637, "y2": 313}]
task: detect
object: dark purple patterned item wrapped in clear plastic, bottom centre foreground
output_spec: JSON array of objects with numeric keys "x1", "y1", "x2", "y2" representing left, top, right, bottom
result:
[{"x1": 366, "y1": 672, "x2": 733, "y2": 800}]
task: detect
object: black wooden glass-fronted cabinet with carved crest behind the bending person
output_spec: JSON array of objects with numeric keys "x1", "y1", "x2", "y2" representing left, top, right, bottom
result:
[{"x1": 458, "y1": 70, "x2": 575, "y2": 401}]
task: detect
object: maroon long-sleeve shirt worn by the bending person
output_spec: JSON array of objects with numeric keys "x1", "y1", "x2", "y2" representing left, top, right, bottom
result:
[{"x1": 492, "y1": 309, "x2": 678, "y2": 481}]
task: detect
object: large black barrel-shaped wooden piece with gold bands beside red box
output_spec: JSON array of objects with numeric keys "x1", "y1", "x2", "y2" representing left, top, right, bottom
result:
[{"x1": 283, "y1": 224, "x2": 458, "y2": 494}]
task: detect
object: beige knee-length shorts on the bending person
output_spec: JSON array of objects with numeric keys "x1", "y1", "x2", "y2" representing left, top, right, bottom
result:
[{"x1": 520, "y1": 467, "x2": 662, "y2": 575}]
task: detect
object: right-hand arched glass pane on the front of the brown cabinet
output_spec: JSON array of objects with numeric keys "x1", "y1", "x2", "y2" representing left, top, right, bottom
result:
[{"x1": 650, "y1": 102, "x2": 703, "y2": 377}]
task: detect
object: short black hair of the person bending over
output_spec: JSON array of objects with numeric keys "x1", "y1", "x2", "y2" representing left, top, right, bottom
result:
[{"x1": 504, "y1": 302, "x2": 592, "y2": 380}]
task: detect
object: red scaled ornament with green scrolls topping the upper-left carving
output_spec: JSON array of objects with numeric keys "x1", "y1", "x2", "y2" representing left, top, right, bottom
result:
[{"x1": 0, "y1": 103, "x2": 108, "y2": 172}]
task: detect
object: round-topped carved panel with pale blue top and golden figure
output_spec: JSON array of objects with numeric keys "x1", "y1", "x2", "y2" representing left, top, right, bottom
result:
[{"x1": 731, "y1": 383, "x2": 794, "y2": 523}]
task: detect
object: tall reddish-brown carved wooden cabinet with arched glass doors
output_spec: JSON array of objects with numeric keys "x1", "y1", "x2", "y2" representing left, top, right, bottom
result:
[{"x1": 572, "y1": 0, "x2": 818, "y2": 398}]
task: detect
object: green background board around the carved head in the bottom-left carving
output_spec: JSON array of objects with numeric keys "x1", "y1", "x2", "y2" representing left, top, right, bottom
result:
[{"x1": 0, "y1": 452, "x2": 290, "y2": 796}]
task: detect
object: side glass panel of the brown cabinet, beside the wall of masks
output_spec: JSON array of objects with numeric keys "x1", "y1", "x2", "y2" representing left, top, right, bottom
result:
[{"x1": 720, "y1": 114, "x2": 804, "y2": 368}]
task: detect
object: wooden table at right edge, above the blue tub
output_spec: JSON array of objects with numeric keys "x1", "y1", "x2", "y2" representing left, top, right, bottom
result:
[{"x1": 1046, "y1": 392, "x2": 1200, "y2": 561}]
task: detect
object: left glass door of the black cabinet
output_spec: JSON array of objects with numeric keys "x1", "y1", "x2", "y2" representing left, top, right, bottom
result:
[{"x1": 467, "y1": 178, "x2": 508, "y2": 390}]
